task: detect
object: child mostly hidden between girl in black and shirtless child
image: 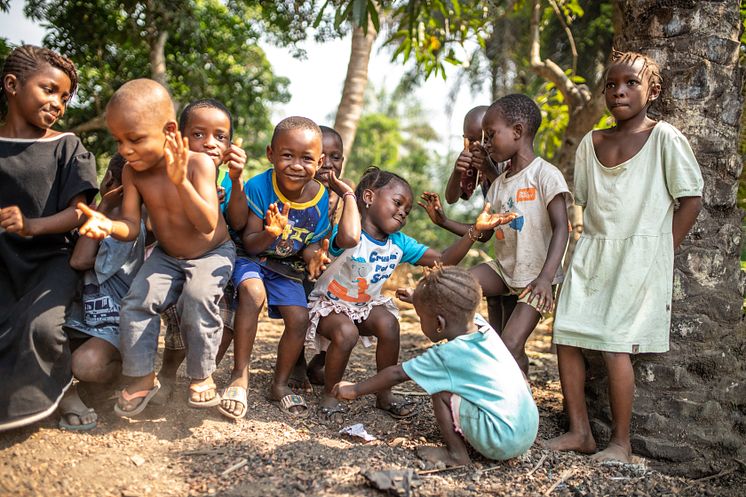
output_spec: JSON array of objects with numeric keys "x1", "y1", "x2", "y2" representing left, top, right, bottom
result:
[{"x1": 59, "y1": 154, "x2": 146, "y2": 430}]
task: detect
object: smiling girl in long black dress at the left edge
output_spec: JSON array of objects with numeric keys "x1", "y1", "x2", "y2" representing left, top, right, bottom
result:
[{"x1": 0, "y1": 45, "x2": 97, "y2": 431}]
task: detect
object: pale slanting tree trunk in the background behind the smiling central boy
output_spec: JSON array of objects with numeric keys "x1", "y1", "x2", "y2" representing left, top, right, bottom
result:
[{"x1": 334, "y1": 21, "x2": 377, "y2": 172}]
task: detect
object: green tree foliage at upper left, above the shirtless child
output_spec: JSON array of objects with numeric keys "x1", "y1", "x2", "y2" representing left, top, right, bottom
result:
[{"x1": 26, "y1": 0, "x2": 290, "y2": 168}]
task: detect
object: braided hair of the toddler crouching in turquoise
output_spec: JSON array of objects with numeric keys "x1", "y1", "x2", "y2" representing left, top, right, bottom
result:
[{"x1": 414, "y1": 265, "x2": 482, "y2": 321}]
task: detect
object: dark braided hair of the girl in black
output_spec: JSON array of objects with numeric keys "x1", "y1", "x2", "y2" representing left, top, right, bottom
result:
[{"x1": 0, "y1": 45, "x2": 78, "y2": 116}]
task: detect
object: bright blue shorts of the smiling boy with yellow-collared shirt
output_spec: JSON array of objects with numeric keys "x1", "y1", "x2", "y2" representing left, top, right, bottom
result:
[{"x1": 233, "y1": 257, "x2": 308, "y2": 319}]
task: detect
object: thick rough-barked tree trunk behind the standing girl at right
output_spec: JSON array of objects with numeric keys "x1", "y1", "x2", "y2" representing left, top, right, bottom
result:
[{"x1": 587, "y1": 0, "x2": 746, "y2": 476}]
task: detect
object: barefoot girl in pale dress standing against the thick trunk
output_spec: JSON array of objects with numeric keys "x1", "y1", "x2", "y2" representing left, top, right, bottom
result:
[{"x1": 547, "y1": 51, "x2": 703, "y2": 462}]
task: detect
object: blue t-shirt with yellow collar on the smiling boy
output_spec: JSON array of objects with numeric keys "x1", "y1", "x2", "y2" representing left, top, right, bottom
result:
[{"x1": 244, "y1": 169, "x2": 331, "y2": 281}]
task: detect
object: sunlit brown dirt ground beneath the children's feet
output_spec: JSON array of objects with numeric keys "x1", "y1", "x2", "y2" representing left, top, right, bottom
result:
[{"x1": 0, "y1": 298, "x2": 746, "y2": 497}]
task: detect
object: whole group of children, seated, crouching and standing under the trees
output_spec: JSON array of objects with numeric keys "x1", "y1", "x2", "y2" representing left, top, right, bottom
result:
[{"x1": 0, "y1": 46, "x2": 702, "y2": 464}]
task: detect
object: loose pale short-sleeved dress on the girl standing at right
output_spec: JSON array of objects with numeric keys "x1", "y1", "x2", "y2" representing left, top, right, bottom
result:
[{"x1": 554, "y1": 122, "x2": 703, "y2": 353}]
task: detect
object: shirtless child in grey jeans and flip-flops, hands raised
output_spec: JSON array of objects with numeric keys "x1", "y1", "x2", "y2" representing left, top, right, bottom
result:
[{"x1": 79, "y1": 79, "x2": 235, "y2": 417}]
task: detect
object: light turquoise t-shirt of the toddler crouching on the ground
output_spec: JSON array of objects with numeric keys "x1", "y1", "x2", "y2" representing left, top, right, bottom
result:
[{"x1": 402, "y1": 315, "x2": 539, "y2": 460}]
